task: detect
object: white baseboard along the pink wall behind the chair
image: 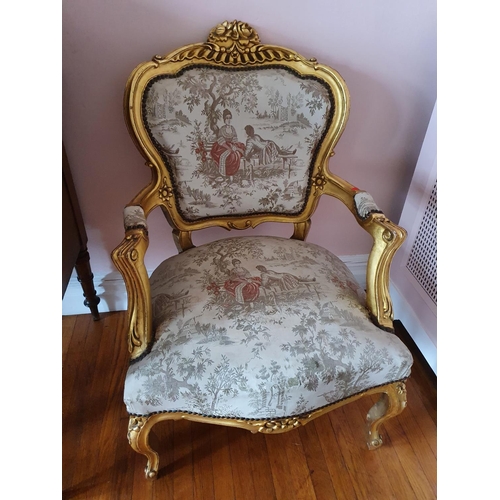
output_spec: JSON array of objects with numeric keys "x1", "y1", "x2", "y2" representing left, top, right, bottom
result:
[{"x1": 62, "y1": 255, "x2": 368, "y2": 316}]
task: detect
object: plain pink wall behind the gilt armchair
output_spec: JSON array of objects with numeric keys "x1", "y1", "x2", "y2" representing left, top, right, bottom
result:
[{"x1": 62, "y1": 0, "x2": 436, "y2": 275}]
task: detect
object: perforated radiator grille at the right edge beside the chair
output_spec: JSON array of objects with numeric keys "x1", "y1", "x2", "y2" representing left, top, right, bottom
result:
[{"x1": 406, "y1": 181, "x2": 437, "y2": 305}]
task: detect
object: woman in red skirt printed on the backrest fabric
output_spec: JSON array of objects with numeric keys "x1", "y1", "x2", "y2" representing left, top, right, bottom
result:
[{"x1": 210, "y1": 109, "x2": 245, "y2": 180}]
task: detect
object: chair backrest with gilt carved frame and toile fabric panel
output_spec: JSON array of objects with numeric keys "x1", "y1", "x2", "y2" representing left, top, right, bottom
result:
[{"x1": 124, "y1": 21, "x2": 349, "y2": 242}]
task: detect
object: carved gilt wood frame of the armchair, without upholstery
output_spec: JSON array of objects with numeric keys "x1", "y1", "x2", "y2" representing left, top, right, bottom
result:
[{"x1": 112, "y1": 21, "x2": 406, "y2": 478}]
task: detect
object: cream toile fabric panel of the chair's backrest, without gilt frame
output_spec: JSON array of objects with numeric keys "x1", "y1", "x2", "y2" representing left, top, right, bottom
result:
[{"x1": 143, "y1": 67, "x2": 333, "y2": 220}]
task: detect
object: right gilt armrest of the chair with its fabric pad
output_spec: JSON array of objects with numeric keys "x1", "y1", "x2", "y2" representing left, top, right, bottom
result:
[{"x1": 324, "y1": 173, "x2": 406, "y2": 332}]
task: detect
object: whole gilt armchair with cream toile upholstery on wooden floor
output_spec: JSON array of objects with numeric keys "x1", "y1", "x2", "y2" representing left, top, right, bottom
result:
[{"x1": 112, "y1": 21, "x2": 412, "y2": 478}]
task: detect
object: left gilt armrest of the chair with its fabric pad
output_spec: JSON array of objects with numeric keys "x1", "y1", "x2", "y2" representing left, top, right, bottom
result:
[{"x1": 111, "y1": 206, "x2": 152, "y2": 360}]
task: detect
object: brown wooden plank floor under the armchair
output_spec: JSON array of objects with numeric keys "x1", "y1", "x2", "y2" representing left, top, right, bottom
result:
[{"x1": 62, "y1": 312, "x2": 437, "y2": 500}]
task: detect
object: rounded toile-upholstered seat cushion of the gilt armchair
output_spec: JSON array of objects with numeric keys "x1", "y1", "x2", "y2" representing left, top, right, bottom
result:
[{"x1": 124, "y1": 236, "x2": 412, "y2": 419}]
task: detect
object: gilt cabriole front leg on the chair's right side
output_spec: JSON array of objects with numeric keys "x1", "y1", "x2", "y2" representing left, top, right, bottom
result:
[{"x1": 366, "y1": 382, "x2": 406, "y2": 450}]
